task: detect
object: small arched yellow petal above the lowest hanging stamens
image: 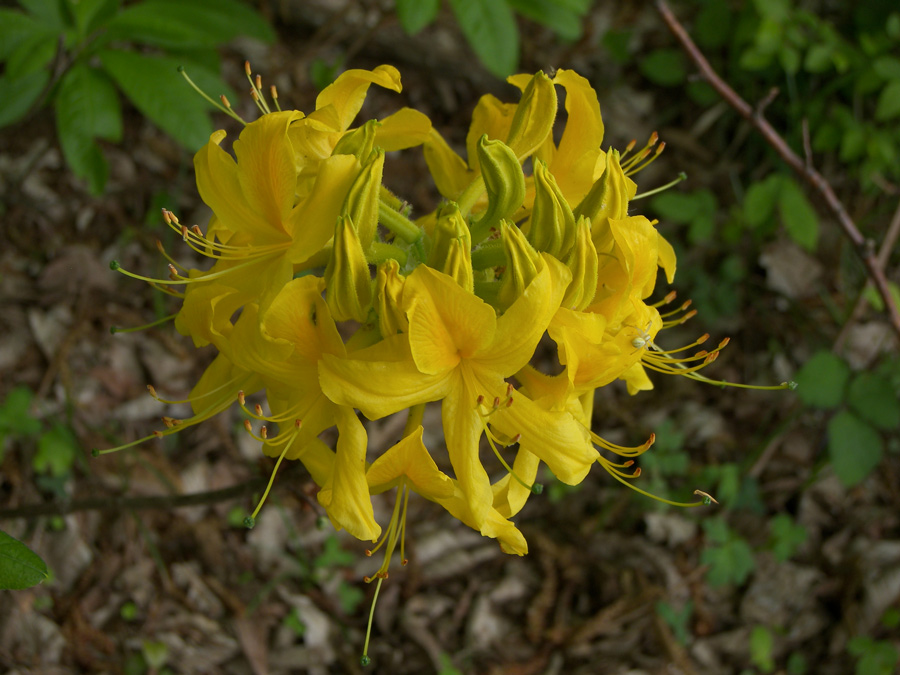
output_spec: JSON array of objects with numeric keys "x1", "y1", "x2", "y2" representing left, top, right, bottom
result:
[{"x1": 366, "y1": 426, "x2": 453, "y2": 500}]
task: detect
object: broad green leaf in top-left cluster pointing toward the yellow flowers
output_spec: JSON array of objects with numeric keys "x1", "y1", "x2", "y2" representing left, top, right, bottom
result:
[{"x1": 98, "y1": 50, "x2": 221, "y2": 152}]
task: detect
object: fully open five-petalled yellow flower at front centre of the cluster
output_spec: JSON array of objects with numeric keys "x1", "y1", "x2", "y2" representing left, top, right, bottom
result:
[{"x1": 319, "y1": 256, "x2": 596, "y2": 533}]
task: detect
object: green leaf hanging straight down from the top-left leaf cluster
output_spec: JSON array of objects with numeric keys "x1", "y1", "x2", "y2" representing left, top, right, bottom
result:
[{"x1": 56, "y1": 63, "x2": 122, "y2": 194}]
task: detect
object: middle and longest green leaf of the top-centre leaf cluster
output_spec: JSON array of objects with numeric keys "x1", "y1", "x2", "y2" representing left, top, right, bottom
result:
[{"x1": 450, "y1": 0, "x2": 519, "y2": 78}]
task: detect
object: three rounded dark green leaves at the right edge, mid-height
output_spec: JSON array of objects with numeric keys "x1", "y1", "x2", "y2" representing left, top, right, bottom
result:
[{"x1": 797, "y1": 351, "x2": 900, "y2": 487}]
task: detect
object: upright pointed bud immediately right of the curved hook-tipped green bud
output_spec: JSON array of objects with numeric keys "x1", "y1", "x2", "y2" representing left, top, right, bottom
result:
[{"x1": 522, "y1": 160, "x2": 575, "y2": 260}]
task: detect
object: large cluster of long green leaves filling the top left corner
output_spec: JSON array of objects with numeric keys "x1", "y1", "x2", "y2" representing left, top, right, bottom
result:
[{"x1": 0, "y1": 0, "x2": 274, "y2": 194}]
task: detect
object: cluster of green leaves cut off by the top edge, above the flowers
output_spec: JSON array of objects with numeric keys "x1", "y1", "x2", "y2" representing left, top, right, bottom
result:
[{"x1": 394, "y1": 0, "x2": 592, "y2": 77}]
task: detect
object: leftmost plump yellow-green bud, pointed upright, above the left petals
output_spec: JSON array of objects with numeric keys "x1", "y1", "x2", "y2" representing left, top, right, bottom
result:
[{"x1": 325, "y1": 215, "x2": 377, "y2": 323}]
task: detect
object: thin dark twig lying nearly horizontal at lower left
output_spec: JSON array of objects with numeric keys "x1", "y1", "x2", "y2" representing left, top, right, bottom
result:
[{"x1": 0, "y1": 477, "x2": 268, "y2": 518}]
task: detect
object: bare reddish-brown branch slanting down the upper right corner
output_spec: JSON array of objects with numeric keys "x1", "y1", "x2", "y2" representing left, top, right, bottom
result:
[{"x1": 656, "y1": 0, "x2": 900, "y2": 336}]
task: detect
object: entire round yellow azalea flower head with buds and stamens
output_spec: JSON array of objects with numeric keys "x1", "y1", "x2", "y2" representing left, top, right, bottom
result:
[{"x1": 103, "y1": 66, "x2": 788, "y2": 660}]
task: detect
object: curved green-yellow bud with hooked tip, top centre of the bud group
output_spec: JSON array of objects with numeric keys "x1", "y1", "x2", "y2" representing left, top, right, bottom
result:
[{"x1": 472, "y1": 134, "x2": 525, "y2": 243}]
